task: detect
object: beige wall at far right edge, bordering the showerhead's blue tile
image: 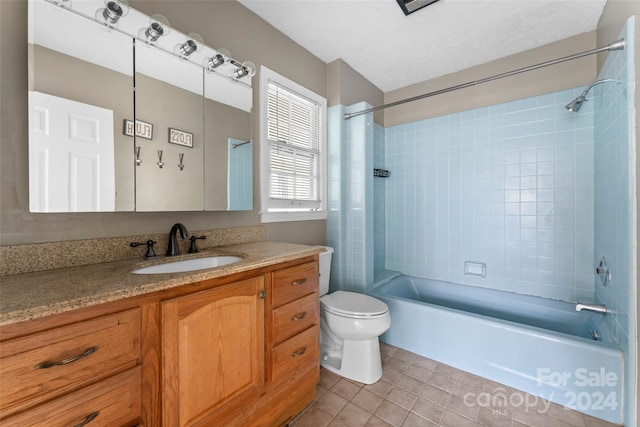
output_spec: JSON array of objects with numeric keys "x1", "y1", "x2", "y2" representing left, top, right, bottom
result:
[{"x1": 597, "y1": 0, "x2": 640, "y2": 422}]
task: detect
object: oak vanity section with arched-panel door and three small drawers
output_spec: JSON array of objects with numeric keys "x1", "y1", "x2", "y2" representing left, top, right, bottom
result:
[{"x1": 162, "y1": 259, "x2": 320, "y2": 427}]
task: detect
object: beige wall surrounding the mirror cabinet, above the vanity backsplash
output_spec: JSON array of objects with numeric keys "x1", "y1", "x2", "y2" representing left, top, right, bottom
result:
[{"x1": 0, "y1": 0, "x2": 327, "y2": 245}]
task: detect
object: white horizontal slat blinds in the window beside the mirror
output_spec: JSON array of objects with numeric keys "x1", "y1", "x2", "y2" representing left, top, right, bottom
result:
[{"x1": 267, "y1": 82, "x2": 321, "y2": 211}]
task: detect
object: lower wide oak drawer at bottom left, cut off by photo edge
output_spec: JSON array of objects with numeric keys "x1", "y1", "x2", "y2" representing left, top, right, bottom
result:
[{"x1": 2, "y1": 367, "x2": 141, "y2": 427}]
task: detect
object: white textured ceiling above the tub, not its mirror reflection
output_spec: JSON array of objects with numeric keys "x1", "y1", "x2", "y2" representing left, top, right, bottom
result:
[{"x1": 238, "y1": 0, "x2": 606, "y2": 92}]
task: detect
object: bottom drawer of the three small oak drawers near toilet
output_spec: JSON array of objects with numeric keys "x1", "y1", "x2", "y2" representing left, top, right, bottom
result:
[{"x1": 271, "y1": 325, "x2": 320, "y2": 382}]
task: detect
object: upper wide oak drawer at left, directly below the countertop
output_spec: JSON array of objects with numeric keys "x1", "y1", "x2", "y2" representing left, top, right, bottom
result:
[{"x1": 0, "y1": 309, "x2": 140, "y2": 417}]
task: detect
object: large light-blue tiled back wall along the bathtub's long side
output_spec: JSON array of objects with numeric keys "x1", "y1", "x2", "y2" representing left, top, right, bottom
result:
[{"x1": 385, "y1": 88, "x2": 594, "y2": 301}]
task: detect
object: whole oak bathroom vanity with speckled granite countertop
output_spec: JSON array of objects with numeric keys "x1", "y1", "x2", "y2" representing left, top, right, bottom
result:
[{"x1": 0, "y1": 242, "x2": 322, "y2": 427}]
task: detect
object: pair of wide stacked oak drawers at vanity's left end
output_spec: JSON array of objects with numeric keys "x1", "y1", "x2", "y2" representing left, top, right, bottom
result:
[{"x1": 0, "y1": 308, "x2": 141, "y2": 426}]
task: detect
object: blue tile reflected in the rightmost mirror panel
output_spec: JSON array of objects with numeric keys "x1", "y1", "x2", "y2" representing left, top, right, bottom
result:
[{"x1": 227, "y1": 138, "x2": 253, "y2": 211}]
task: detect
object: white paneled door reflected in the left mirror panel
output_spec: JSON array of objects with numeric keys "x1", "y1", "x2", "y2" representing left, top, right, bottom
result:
[{"x1": 29, "y1": 92, "x2": 115, "y2": 212}]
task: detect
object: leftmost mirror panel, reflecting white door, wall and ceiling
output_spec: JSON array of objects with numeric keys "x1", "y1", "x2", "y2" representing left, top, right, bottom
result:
[{"x1": 28, "y1": 0, "x2": 134, "y2": 212}]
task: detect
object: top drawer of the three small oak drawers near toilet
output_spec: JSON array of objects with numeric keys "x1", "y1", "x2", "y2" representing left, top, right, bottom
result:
[{"x1": 271, "y1": 262, "x2": 318, "y2": 307}]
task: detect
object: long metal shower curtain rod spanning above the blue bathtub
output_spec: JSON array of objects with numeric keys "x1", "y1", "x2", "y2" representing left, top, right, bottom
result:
[{"x1": 344, "y1": 39, "x2": 625, "y2": 120}]
